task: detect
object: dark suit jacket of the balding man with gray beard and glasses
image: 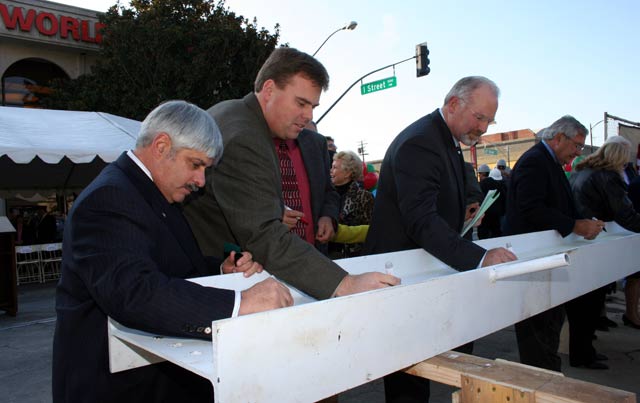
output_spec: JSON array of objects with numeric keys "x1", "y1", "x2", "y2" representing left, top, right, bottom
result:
[{"x1": 365, "y1": 110, "x2": 485, "y2": 270}]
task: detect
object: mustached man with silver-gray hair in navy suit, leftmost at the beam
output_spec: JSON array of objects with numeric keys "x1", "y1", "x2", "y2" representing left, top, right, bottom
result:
[{"x1": 53, "y1": 101, "x2": 293, "y2": 403}]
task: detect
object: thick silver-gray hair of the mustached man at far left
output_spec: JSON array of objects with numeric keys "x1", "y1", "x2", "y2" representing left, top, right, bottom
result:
[{"x1": 136, "y1": 101, "x2": 223, "y2": 161}]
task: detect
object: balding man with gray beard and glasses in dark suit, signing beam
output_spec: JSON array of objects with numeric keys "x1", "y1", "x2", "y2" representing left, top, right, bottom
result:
[{"x1": 365, "y1": 77, "x2": 516, "y2": 402}]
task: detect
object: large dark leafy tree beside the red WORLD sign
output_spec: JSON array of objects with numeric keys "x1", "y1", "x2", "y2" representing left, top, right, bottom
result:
[{"x1": 45, "y1": 0, "x2": 280, "y2": 120}]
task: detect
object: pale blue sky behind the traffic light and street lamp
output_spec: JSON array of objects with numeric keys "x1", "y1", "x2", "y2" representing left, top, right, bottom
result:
[{"x1": 57, "y1": 0, "x2": 640, "y2": 160}]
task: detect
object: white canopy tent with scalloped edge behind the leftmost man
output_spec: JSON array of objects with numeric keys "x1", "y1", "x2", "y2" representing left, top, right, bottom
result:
[{"x1": 0, "y1": 107, "x2": 140, "y2": 198}]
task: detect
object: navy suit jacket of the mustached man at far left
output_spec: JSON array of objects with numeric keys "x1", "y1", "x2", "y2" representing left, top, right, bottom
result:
[{"x1": 53, "y1": 154, "x2": 235, "y2": 403}]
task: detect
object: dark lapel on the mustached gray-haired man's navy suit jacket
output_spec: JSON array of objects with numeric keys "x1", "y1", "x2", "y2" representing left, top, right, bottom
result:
[{"x1": 115, "y1": 153, "x2": 210, "y2": 274}]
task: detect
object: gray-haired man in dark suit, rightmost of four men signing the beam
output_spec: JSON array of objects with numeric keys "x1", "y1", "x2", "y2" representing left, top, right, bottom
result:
[{"x1": 505, "y1": 116, "x2": 604, "y2": 371}]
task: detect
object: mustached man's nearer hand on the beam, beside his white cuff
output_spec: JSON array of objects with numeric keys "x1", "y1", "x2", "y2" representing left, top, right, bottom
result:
[{"x1": 238, "y1": 277, "x2": 293, "y2": 315}]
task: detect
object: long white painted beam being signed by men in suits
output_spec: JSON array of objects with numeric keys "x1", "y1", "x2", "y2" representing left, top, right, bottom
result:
[{"x1": 110, "y1": 223, "x2": 640, "y2": 403}]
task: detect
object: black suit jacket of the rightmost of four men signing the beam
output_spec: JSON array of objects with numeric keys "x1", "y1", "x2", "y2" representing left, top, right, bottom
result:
[{"x1": 505, "y1": 142, "x2": 577, "y2": 237}]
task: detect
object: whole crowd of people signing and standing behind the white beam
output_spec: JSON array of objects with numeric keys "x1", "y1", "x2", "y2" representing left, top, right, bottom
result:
[{"x1": 53, "y1": 48, "x2": 640, "y2": 402}]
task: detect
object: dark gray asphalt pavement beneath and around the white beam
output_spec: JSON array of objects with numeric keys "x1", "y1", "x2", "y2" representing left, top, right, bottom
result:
[{"x1": 0, "y1": 283, "x2": 640, "y2": 403}]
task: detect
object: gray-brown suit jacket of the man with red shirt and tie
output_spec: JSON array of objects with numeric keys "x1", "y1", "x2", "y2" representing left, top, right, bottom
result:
[{"x1": 184, "y1": 94, "x2": 346, "y2": 298}]
